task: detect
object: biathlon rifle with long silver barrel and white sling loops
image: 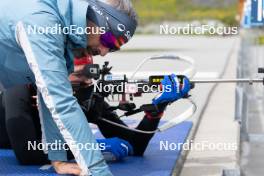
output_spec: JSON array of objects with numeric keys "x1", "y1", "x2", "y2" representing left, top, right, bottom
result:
[{"x1": 73, "y1": 55, "x2": 264, "y2": 131}]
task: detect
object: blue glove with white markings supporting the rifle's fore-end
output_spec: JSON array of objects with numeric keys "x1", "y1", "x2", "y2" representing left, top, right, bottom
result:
[{"x1": 152, "y1": 74, "x2": 191, "y2": 105}]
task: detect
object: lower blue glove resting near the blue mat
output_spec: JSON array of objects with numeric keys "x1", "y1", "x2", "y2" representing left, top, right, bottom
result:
[{"x1": 97, "y1": 137, "x2": 133, "y2": 160}]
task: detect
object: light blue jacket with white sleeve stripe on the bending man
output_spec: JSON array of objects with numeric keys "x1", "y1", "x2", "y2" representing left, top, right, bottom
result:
[{"x1": 0, "y1": 0, "x2": 111, "y2": 176}]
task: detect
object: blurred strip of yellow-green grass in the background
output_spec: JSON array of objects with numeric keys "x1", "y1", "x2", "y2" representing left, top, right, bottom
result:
[{"x1": 132, "y1": 0, "x2": 237, "y2": 26}]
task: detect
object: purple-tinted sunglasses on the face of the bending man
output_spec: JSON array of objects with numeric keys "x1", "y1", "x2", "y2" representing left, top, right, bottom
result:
[{"x1": 100, "y1": 32, "x2": 125, "y2": 52}]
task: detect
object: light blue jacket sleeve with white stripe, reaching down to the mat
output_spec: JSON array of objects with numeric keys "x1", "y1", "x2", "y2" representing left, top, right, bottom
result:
[{"x1": 16, "y1": 20, "x2": 111, "y2": 175}]
